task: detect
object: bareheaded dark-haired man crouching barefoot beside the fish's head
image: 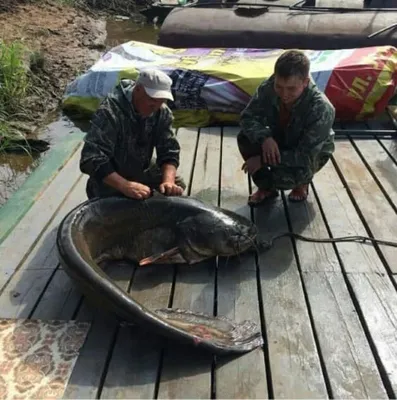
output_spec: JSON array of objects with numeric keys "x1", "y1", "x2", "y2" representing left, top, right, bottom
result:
[{"x1": 237, "y1": 50, "x2": 335, "y2": 206}]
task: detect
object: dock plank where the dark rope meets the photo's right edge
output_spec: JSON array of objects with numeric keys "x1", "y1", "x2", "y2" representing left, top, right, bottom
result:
[{"x1": 334, "y1": 141, "x2": 397, "y2": 273}]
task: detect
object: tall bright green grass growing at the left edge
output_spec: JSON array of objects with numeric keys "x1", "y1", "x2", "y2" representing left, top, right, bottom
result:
[{"x1": 0, "y1": 40, "x2": 30, "y2": 152}]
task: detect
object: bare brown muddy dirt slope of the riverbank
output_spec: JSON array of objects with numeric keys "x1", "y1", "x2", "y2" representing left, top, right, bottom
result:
[{"x1": 0, "y1": 0, "x2": 106, "y2": 133}]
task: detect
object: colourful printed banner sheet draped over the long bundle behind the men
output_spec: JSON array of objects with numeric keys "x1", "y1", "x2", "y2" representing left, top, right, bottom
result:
[{"x1": 63, "y1": 41, "x2": 397, "y2": 127}]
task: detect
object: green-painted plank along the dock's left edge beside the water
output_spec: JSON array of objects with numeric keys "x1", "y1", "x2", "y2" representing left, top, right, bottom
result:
[{"x1": 0, "y1": 132, "x2": 84, "y2": 244}]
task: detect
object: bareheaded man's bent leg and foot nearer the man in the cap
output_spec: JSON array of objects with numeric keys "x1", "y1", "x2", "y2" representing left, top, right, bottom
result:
[{"x1": 237, "y1": 131, "x2": 278, "y2": 207}]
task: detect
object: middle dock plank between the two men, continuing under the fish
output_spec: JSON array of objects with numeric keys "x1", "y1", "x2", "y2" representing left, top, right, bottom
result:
[{"x1": 158, "y1": 128, "x2": 221, "y2": 398}]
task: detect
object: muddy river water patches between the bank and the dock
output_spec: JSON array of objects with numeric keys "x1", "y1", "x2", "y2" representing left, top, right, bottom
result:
[{"x1": 0, "y1": 19, "x2": 159, "y2": 207}]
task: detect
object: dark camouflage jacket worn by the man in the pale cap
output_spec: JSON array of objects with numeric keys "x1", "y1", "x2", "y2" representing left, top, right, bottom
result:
[{"x1": 80, "y1": 79, "x2": 180, "y2": 183}]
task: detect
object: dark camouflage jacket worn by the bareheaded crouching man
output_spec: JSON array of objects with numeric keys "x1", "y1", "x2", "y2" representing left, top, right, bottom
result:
[{"x1": 240, "y1": 75, "x2": 335, "y2": 169}]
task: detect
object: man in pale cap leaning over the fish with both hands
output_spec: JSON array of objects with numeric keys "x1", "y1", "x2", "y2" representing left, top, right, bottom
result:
[{"x1": 80, "y1": 70, "x2": 186, "y2": 199}]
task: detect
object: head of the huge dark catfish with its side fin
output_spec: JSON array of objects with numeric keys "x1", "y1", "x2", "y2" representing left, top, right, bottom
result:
[{"x1": 139, "y1": 209, "x2": 258, "y2": 265}]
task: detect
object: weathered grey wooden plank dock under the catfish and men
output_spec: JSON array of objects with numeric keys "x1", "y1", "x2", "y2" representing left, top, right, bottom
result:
[{"x1": 0, "y1": 115, "x2": 397, "y2": 399}]
